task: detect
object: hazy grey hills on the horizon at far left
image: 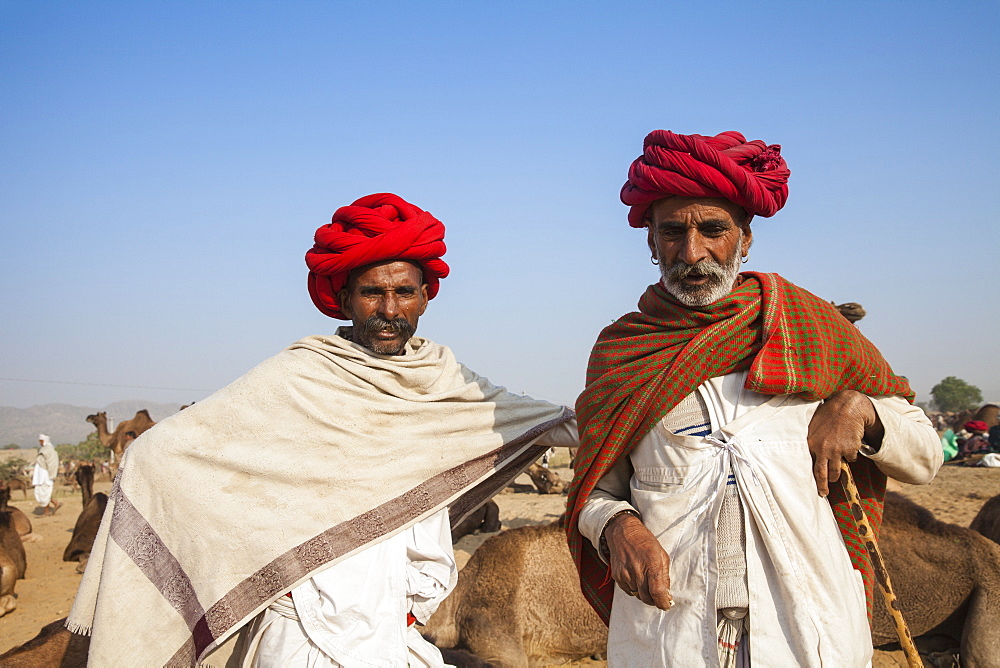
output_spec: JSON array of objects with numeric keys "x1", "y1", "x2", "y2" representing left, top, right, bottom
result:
[{"x1": 0, "y1": 399, "x2": 181, "y2": 448}]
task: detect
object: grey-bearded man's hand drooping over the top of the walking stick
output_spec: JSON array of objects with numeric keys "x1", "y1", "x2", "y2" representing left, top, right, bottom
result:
[{"x1": 807, "y1": 390, "x2": 885, "y2": 496}]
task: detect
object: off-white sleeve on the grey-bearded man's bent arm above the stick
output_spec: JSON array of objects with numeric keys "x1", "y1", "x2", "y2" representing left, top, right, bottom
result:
[{"x1": 861, "y1": 397, "x2": 944, "y2": 485}]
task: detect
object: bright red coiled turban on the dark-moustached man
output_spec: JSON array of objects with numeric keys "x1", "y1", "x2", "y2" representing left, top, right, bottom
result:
[{"x1": 306, "y1": 193, "x2": 449, "y2": 320}]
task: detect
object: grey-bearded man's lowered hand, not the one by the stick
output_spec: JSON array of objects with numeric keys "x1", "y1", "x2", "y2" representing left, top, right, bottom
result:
[{"x1": 604, "y1": 514, "x2": 674, "y2": 610}]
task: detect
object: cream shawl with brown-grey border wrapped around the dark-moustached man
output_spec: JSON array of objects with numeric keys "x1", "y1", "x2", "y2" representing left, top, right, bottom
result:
[{"x1": 67, "y1": 336, "x2": 572, "y2": 666}]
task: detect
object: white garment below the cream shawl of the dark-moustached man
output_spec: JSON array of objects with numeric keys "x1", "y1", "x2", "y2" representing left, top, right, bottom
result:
[{"x1": 243, "y1": 509, "x2": 458, "y2": 668}]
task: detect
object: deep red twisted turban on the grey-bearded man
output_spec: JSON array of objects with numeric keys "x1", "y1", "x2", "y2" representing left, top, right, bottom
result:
[{"x1": 622, "y1": 130, "x2": 791, "y2": 227}]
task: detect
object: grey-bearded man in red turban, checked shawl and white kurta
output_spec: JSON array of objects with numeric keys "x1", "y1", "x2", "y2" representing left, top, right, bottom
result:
[{"x1": 567, "y1": 130, "x2": 941, "y2": 666}]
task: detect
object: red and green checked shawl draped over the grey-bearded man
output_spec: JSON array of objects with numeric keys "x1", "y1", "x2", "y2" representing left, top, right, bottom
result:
[{"x1": 567, "y1": 272, "x2": 913, "y2": 623}]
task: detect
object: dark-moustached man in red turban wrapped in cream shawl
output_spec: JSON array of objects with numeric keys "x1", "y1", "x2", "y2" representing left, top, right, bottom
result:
[{"x1": 67, "y1": 194, "x2": 576, "y2": 667}]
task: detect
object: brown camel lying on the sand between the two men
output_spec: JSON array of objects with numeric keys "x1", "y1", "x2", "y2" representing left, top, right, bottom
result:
[{"x1": 423, "y1": 523, "x2": 608, "y2": 668}]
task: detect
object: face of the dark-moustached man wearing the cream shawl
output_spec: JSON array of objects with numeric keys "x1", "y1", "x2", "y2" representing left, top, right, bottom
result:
[{"x1": 338, "y1": 260, "x2": 427, "y2": 355}]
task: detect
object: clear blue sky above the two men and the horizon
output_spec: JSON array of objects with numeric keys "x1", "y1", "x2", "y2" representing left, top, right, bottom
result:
[{"x1": 0, "y1": 0, "x2": 1000, "y2": 407}]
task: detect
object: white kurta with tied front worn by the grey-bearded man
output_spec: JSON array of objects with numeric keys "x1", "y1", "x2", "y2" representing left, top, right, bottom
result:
[{"x1": 580, "y1": 372, "x2": 941, "y2": 667}]
